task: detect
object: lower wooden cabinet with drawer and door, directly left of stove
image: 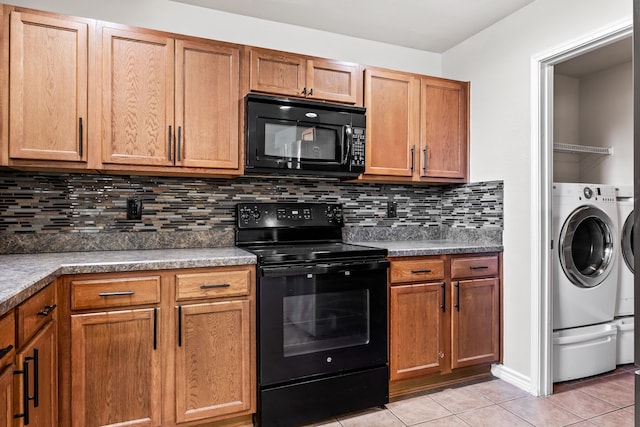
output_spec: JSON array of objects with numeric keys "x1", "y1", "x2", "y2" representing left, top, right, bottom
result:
[{"x1": 175, "y1": 267, "x2": 255, "y2": 423}]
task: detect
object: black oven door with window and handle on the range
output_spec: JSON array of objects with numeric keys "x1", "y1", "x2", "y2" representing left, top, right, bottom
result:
[{"x1": 258, "y1": 260, "x2": 389, "y2": 387}]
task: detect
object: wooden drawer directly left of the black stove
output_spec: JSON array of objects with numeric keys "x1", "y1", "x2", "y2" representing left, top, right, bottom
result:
[{"x1": 176, "y1": 267, "x2": 253, "y2": 301}]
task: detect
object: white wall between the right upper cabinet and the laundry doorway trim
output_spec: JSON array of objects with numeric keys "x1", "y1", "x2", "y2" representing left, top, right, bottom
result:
[{"x1": 442, "y1": 0, "x2": 632, "y2": 394}]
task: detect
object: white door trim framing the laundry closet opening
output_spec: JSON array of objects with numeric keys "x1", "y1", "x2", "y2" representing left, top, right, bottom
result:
[{"x1": 531, "y1": 22, "x2": 633, "y2": 396}]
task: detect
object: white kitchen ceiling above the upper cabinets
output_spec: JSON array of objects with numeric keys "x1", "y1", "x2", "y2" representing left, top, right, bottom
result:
[{"x1": 174, "y1": 0, "x2": 534, "y2": 53}]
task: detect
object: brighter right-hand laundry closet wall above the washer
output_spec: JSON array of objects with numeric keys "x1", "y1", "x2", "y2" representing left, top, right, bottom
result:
[{"x1": 580, "y1": 62, "x2": 633, "y2": 185}]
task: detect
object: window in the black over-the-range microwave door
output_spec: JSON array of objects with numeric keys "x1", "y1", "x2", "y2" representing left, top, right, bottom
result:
[{"x1": 264, "y1": 123, "x2": 339, "y2": 161}]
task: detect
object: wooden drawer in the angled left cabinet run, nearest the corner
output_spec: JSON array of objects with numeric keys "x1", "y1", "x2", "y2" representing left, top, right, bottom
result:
[{"x1": 18, "y1": 285, "x2": 56, "y2": 347}]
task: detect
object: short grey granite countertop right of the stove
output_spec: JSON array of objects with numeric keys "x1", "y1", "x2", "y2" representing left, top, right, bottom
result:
[{"x1": 352, "y1": 240, "x2": 503, "y2": 257}]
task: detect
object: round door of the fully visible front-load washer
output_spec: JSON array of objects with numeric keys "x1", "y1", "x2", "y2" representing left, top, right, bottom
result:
[{"x1": 558, "y1": 206, "x2": 615, "y2": 288}]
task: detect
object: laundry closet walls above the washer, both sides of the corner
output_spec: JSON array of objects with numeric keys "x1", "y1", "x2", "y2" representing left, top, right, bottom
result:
[{"x1": 553, "y1": 62, "x2": 633, "y2": 185}]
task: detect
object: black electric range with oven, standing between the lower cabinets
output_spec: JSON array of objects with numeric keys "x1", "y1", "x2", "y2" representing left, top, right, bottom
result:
[{"x1": 236, "y1": 203, "x2": 389, "y2": 427}]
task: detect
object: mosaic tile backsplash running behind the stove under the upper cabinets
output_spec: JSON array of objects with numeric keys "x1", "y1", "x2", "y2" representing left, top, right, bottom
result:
[{"x1": 0, "y1": 170, "x2": 503, "y2": 253}]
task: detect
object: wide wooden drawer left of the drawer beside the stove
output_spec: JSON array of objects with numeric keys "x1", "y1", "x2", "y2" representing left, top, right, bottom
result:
[{"x1": 71, "y1": 276, "x2": 160, "y2": 310}]
